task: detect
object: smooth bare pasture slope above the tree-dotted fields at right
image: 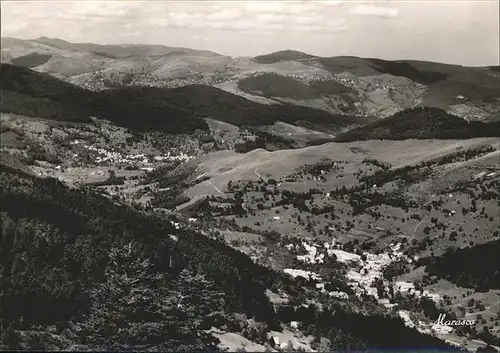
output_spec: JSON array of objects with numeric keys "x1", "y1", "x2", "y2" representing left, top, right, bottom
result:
[{"x1": 187, "y1": 138, "x2": 499, "y2": 197}]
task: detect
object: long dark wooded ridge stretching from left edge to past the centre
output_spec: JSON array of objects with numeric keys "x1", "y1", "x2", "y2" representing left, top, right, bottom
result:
[{"x1": 1, "y1": 64, "x2": 370, "y2": 132}]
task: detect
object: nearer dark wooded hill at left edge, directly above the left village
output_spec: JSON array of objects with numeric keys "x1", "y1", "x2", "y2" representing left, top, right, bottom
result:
[{"x1": 1, "y1": 64, "x2": 203, "y2": 132}]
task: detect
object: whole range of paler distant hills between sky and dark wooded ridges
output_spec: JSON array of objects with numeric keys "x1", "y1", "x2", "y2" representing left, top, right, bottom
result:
[{"x1": 2, "y1": 37, "x2": 500, "y2": 121}]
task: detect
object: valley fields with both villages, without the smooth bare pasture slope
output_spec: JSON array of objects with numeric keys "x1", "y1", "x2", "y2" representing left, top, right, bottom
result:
[{"x1": 2, "y1": 105, "x2": 500, "y2": 348}]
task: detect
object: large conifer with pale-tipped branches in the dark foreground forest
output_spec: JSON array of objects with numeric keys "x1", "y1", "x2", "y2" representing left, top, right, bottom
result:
[{"x1": 74, "y1": 243, "x2": 205, "y2": 350}]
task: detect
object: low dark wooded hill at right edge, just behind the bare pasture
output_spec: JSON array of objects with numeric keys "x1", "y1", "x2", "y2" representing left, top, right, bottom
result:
[{"x1": 335, "y1": 108, "x2": 500, "y2": 142}]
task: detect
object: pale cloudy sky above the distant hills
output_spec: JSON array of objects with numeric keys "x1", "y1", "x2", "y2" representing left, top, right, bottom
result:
[{"x1": 1, "y1": 0, "x2": 500, "y2": 66}]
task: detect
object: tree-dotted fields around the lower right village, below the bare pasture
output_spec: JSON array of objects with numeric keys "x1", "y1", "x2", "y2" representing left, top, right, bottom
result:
[{"x1": 161, "y1": 145, "x2": 500, "y2": 346}]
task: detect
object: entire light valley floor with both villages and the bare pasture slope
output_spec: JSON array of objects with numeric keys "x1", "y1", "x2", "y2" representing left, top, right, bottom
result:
[{"x1": 2, "y1": 115, "x2": 500, "y2": 351}]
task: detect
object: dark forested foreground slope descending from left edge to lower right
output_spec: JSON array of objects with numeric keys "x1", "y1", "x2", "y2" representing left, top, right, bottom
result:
[{"x1": 0, "y1": 166, "x2": 458, "y2": 351}]
